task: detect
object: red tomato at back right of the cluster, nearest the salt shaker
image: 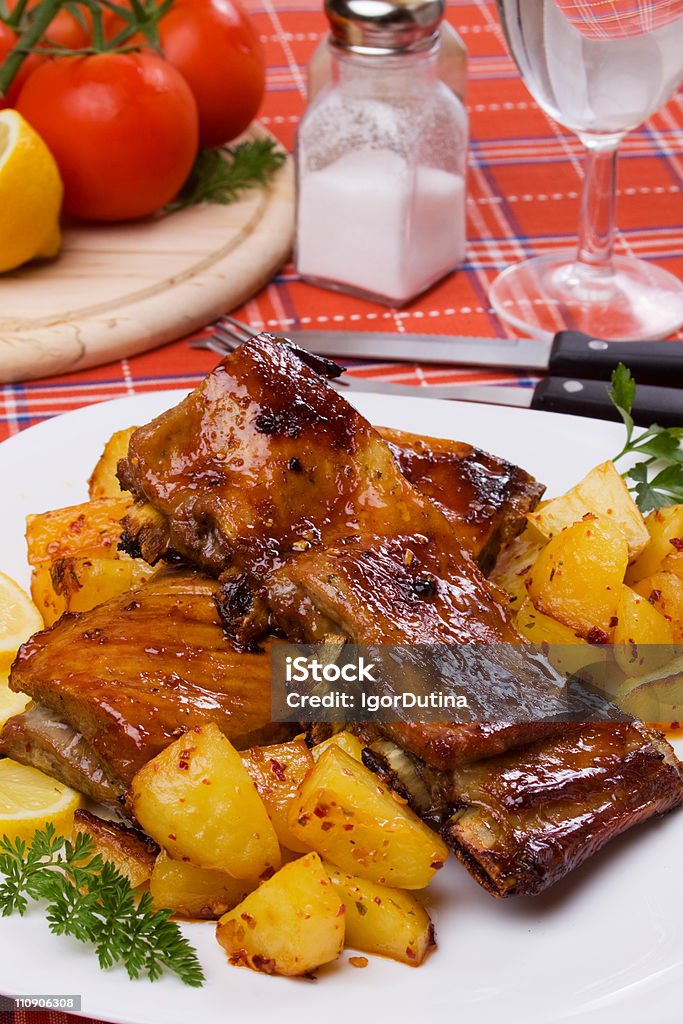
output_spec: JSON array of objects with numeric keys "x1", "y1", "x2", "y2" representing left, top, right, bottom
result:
[{"x1": 105, "y1": 0, "x2": 265, "y2": 146}]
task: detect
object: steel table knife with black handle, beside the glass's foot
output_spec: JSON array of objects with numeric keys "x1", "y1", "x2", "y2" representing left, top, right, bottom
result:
[{"x1": 266, "y1": 330, "x2": 683, "y2": 387}]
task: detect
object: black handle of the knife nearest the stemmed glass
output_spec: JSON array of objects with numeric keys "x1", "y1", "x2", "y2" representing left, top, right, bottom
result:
[{"x1": 548, "y1": 331, "x2": 683, "y2": 387}]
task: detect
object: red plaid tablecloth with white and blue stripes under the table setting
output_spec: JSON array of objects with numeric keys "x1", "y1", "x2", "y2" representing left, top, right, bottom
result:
[{"x1": 0, "y1": 0, "x2": 683, "y2": 1024}]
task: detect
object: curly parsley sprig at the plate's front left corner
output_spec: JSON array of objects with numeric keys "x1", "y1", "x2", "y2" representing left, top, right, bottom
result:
[{"x1": 0, "y1": 824, "x2": 204, "y2": 987}]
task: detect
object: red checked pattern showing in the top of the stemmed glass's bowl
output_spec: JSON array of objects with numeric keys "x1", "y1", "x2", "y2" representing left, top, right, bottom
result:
[{"x1": 555, "y1": 0, "x2": 683, "y2": 39}]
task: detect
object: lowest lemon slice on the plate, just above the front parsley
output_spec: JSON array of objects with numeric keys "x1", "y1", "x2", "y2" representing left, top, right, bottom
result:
[{"x1": 0, "y1": 758, "x2": 83, "y2": 842}]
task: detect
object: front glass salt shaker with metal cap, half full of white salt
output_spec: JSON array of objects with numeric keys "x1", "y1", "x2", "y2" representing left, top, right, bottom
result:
[{"x1": 296, "y1": 0, "x2": 467, "y2": 306}]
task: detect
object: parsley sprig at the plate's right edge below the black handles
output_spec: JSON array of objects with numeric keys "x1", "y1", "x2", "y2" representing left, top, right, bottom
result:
[{"x1": 609, "y1": 362, "x2": 683, "y2": 513}]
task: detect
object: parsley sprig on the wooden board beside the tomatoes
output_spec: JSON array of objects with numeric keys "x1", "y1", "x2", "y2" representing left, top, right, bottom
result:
[{"x1": 166, "y1": 138, "x2": 287, "y2": 212}]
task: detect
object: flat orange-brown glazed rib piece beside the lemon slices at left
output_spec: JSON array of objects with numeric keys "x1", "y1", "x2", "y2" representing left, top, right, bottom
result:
[{"x1": 0, "y1": 568, "x2": 289, "y2": 788}]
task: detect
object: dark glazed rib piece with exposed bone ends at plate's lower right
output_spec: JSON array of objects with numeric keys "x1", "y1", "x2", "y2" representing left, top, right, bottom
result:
[{"x1": 356, "y1": 722, "x2": 683, "y2": 897}]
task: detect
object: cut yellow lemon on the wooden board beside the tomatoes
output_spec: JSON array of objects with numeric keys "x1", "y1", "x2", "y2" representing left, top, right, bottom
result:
[{"x1": 0, "y1": 110, "x2": 63, "y2": 271}]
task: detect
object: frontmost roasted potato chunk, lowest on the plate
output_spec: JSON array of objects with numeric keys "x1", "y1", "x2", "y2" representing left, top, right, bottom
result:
[{"x1": 216, "y1": 853, "x2": 344, "y2": 977}]
